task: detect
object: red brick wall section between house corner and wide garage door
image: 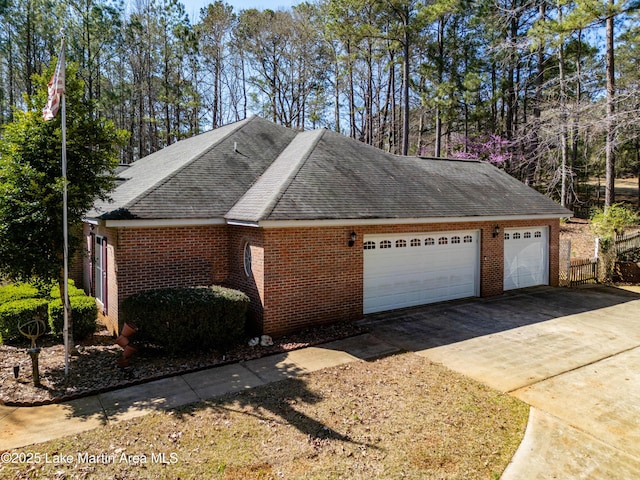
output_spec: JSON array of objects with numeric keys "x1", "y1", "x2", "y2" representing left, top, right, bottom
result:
[{"x1": 263, "y1": 227, "x2": 363, "y2": 335}]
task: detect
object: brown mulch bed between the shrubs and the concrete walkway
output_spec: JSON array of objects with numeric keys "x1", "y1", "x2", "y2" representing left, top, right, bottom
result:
[{"x1": 0, "y1": 323, "x2": 363, "y2": 406}]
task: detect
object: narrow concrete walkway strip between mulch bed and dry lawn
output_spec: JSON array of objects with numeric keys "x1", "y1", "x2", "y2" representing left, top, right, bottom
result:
[{"x1": 0, "y1": 334, "x2": 397, "y2": 451}]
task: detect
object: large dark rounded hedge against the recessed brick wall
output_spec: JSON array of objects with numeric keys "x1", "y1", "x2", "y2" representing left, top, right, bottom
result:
[{"x1": 119, "y1": 286, "x2": 249, "y2": 354}]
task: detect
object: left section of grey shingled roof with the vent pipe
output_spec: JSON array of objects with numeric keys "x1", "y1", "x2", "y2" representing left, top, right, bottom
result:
[{"x1": 87, "y1": 117, "x2": 296, "y2": 220}]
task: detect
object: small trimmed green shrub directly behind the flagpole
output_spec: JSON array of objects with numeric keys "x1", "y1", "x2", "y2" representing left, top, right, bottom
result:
[{"x1": 49, "y1": 292, "x2": 98, "y2": 341}]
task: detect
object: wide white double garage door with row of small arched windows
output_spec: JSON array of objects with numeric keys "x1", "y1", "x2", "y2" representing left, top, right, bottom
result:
[{"x1": 364, "y1": 230, "x2": 480, "y2": 313}]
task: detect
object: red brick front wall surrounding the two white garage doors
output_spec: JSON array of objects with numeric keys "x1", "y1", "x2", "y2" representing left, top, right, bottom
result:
[{"x1": 252, "y1": 220, "x2": 559, "y2": 335}]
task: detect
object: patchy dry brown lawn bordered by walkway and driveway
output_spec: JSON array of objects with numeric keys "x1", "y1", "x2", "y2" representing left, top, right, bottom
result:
[{"x1": 0, "y1": 353, "x2": 528, "y2": 480}]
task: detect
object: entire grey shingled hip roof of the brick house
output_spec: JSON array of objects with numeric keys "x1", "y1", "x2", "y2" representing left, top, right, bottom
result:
[{"x1": 88, "y1": 117, "x2": 571, "y2": 224}]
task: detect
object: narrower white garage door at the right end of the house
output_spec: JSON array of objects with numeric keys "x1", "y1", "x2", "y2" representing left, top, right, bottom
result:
[{"x1": 504, "y1": 227, "x2": 549, "y2": 290}]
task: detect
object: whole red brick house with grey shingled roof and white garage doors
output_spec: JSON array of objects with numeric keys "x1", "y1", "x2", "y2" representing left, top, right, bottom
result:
[{"x1": 77, "y1": 117, "x2": 571, "y2": 336}]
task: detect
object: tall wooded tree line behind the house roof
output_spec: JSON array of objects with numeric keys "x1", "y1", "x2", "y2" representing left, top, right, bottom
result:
[{"x1": 0, "y1": 0, "x2": 640, "y2": 206}]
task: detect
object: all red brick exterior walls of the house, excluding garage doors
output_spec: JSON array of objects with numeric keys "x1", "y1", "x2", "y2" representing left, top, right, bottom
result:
[{"x1": 84, "y1": 220, "x2": 559, "y2": 336}]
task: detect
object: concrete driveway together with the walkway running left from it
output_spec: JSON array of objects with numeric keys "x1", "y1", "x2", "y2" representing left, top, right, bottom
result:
[{"x1": 0, "y1": 286, "x2": 640, "y2": 480}]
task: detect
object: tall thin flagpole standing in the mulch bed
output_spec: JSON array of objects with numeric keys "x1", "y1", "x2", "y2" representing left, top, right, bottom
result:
[{"x1": 60, "y1": 28, "x2": 70, "y2": 376}]
